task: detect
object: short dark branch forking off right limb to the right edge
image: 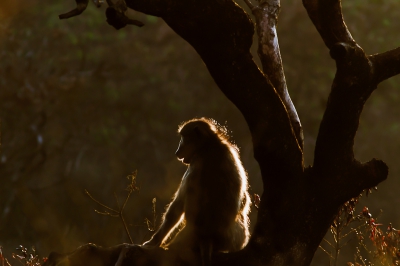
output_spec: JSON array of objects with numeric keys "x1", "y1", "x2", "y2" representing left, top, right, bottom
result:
[{"x1": 368, "y1": 47, "x2": 400, "y2": 83}]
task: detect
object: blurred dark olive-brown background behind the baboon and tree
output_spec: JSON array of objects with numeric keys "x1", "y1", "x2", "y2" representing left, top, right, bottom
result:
[{"x1": 0, "y1": 0, "x2": 400, "y2": 265}]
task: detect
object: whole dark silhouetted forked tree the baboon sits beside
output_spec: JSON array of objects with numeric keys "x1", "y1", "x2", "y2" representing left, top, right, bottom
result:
[{"x1": 43, "y1": 0, "x2": 400, "y2": 265}]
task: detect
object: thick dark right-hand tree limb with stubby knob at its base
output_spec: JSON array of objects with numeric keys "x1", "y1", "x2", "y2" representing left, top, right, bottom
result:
[{"x1": 303, "y1": 0, "x2": 387, "y2": 194}]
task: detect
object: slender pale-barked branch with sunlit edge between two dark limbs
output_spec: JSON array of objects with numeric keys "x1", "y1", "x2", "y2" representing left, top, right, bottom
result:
[{"x1": 246, "y1": 0, "x2": 303, "y2": 149}]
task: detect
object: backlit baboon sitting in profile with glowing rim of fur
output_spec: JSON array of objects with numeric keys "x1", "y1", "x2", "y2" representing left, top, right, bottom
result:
[{"x1": 144, "y1": 118, "x2": 250, "y2": 264}]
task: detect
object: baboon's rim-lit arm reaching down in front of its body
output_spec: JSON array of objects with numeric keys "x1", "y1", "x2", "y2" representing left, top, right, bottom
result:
[{"x1": 143, "y1": 191, "x2": 184, "y2": 246}]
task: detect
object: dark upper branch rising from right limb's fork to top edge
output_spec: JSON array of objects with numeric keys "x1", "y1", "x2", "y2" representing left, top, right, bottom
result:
[{"x1": 303, "y1": 0, "x2": 355, "y2": 49}]
